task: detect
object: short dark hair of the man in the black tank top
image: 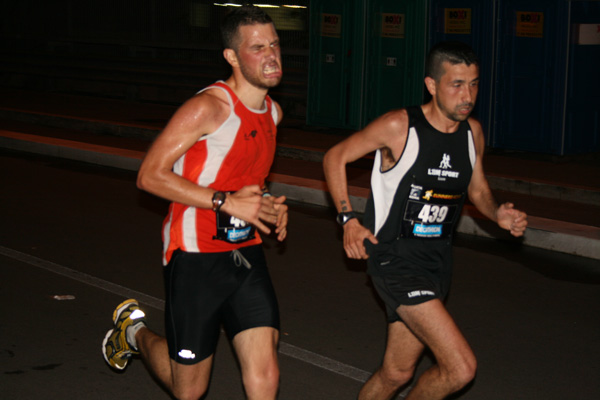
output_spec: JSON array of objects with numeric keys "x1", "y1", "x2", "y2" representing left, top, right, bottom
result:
[{"x1": 425, "y1": 41, "x2": 479, "y2": 82}]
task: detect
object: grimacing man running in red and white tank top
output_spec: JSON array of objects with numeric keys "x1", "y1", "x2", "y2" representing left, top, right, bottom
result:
[{"x1": 102, "y1": 6, "x2": 287, "y2": 399}]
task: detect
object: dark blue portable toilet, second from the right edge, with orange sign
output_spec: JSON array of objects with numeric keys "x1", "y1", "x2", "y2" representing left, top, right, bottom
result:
[{"x1": 493, "y1": 0, "x2": 569, "y2": 154}]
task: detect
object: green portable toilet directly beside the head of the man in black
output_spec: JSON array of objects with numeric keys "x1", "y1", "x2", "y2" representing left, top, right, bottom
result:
[{"x1": 363, "y1": 0, "x2": 428, "y2": 124}]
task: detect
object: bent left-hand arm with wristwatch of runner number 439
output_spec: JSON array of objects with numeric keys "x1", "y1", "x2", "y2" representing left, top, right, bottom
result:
[{"x1": 323, "y1": 110, "x2": 408, "y2": 259}]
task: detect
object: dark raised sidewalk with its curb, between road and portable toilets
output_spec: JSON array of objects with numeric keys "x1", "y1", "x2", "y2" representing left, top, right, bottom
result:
[{"x1": 0, "y1": 88, "x2": 600, "y2": 259}]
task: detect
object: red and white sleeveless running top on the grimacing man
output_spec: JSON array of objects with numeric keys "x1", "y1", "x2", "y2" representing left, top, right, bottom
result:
[{"x1": 163, "y1": 81, "x2": 278, "y2": 265}]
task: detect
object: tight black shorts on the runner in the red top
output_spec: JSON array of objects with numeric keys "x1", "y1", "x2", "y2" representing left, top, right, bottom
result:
[{"x1": 164, "y1": 245, "x2": 279, "y2": 365}]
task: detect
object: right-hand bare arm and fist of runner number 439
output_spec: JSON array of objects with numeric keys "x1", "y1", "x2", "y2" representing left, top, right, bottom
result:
[{"x1": 469, "y1": 119, "x2": 527, "y2": 237}]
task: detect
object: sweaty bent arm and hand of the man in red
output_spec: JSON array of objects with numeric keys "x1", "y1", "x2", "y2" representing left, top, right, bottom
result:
[{"x1": 137, "y1": 90, "x2": 270, "y2": 233}]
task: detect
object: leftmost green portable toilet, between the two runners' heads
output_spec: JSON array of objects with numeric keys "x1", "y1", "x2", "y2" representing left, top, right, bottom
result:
[{"x1": 306, "y1": 0, "x2": 364, "y2": 129}]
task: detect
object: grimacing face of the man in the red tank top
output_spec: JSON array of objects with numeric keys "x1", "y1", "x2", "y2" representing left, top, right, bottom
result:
[{"x1": 235, "y1": 24, "x2": 283, "y2": 89}]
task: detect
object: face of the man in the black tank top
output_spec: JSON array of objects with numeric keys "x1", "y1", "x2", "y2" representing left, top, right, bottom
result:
[{"x1": 432, "y1": 61, "x2": 479, "y2": 122}]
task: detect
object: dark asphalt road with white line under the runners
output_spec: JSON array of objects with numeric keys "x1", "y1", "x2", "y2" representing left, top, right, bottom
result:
[{"x1": 0, "y1": 151, "x2": 600, "y2": 400}]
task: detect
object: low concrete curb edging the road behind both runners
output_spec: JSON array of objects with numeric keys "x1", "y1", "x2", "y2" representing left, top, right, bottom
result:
[{"x1": 0, "y1": 130, "x2": 600, "y2": 260}]
